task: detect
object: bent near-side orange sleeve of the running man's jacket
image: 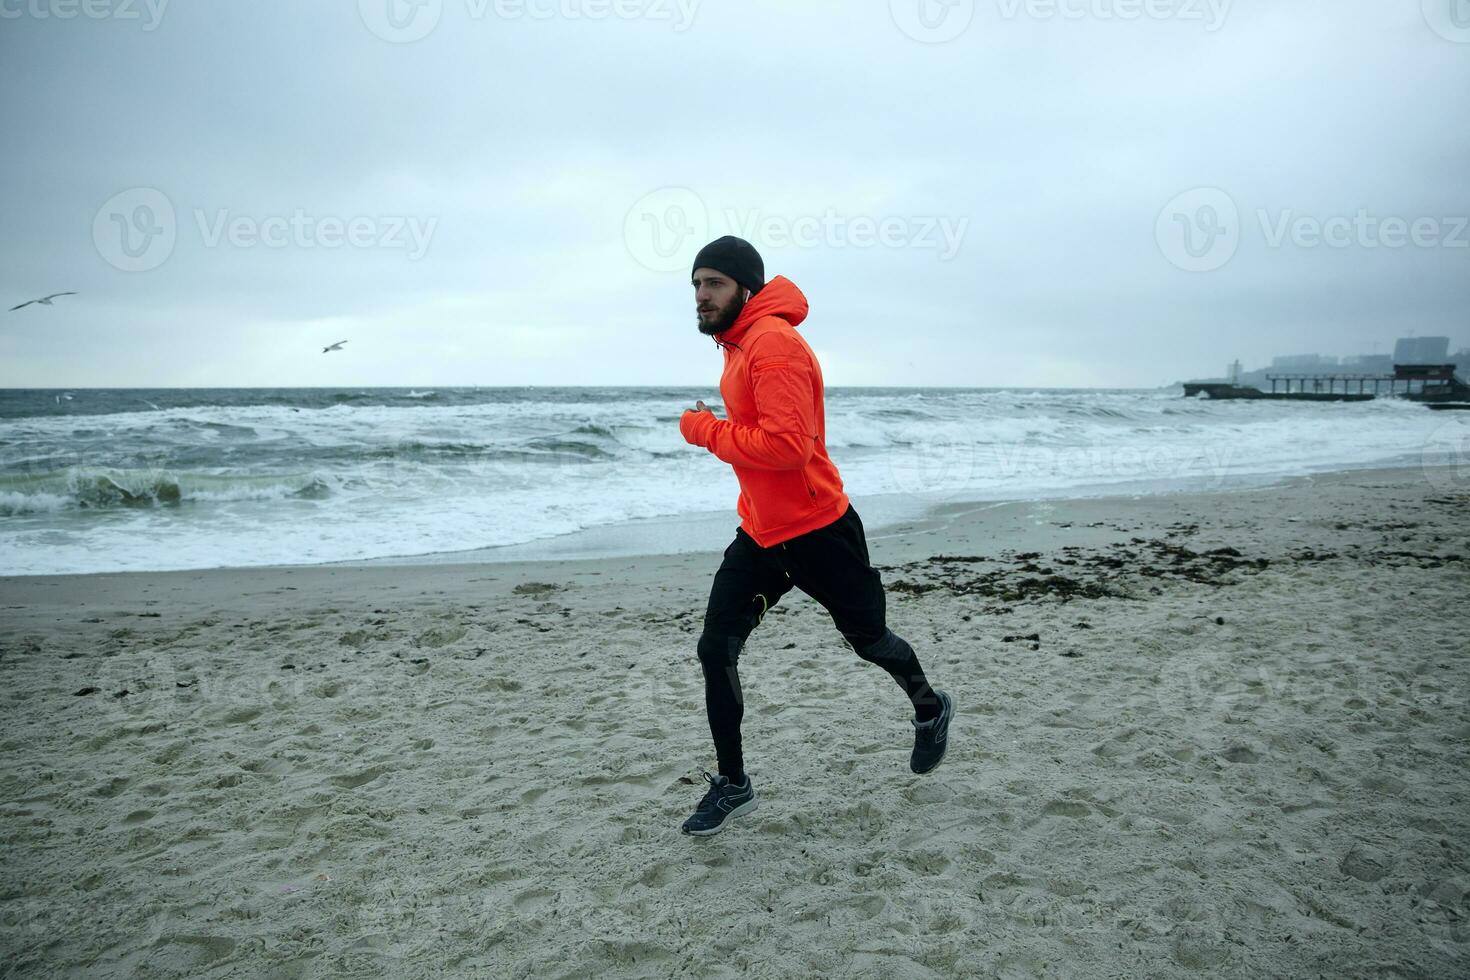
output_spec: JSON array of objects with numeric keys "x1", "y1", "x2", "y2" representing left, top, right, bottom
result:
[{"x1": 679, "y1": 335, "x2": 817, "y2": 470}]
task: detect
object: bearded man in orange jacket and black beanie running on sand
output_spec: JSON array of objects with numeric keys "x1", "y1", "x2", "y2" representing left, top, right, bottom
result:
[{"x1": 679, "y1": 237, "x2": 954, "y2": 836}]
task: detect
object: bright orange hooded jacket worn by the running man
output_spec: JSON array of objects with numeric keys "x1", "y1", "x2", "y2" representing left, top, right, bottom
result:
[{"x1": 679, "y1": 276, "x2": 848, "y2": 548}]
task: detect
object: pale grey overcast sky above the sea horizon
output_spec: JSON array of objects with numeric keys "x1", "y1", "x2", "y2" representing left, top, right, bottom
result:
[{"x1": 0, "y1": 0, "x2": 1470, "y2": 386}]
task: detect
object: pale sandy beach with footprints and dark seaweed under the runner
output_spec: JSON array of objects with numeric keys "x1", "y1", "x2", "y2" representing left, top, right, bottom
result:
[{"x1": 0, "y1": 467, "x2": 1470, "y2": 979}]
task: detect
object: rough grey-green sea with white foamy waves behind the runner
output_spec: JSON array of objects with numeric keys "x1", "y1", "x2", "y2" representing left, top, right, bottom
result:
[{"x1": 0, "y1": 388, "x2": 1467, "y2": 574}]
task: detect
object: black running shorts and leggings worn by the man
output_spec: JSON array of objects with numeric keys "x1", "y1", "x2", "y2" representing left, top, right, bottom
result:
[{"x1": 698, "y1": 507, "x2": 939, "y2": 779}]
